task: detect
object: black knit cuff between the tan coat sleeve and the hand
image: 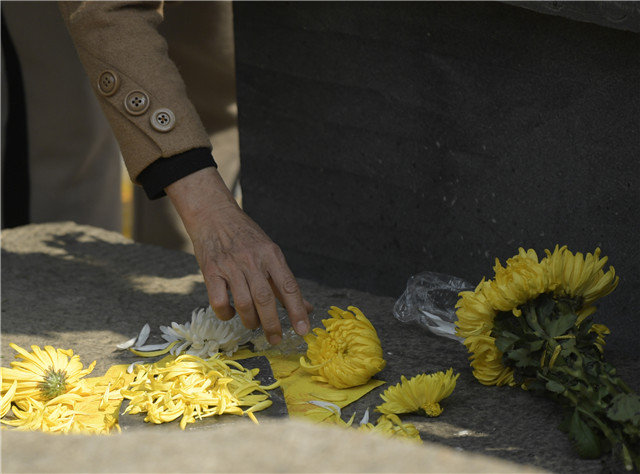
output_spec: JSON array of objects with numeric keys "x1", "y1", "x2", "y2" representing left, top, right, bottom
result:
[{"x1": 138, "y1": 148, "x2": 218, "y2": 200}]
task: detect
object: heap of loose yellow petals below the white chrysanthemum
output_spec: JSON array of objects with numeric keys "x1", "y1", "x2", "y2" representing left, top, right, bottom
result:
[{"x1": 122, "y1": 355, "x2": 279, "y2": 429}]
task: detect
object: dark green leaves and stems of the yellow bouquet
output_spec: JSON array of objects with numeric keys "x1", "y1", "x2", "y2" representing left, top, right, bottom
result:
[{"x1": 492, "y1": 295, "x2": 640, "y2": 470}]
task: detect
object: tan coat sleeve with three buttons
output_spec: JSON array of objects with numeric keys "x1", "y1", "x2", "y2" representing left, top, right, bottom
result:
[{"x1": 59, "y1": 1, "x2": 211, "y2": 181}]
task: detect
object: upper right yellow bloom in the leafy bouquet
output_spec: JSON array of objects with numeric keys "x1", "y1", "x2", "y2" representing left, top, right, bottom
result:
[{"x1": 542, "y1": 245, "x2": 619, "y2": 310}]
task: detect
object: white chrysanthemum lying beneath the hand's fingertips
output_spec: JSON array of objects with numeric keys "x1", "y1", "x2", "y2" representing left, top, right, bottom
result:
[{"x1": 160, "y1": 306, "x2": 252, "y2": 357}]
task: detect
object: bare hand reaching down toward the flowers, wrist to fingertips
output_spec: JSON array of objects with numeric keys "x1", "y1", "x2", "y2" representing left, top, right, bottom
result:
[{"x1": 166, "y1": 168, "x2": 313, "y2": 344}]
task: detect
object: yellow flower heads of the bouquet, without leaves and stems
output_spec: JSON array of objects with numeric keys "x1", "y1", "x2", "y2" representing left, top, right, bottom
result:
[{"x1": 456, "y1": 246, "x2": 618, "y2": 385}]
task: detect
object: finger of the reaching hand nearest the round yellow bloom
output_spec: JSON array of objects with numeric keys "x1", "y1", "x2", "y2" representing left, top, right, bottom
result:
[{"x1": 269, "y1": 259, "x2": 313, "y2": 336}]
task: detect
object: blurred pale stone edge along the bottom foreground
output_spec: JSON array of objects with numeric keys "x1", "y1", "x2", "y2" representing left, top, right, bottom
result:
[{"x1": 2, "y1": 422, "x2": 540, "y2": 473}]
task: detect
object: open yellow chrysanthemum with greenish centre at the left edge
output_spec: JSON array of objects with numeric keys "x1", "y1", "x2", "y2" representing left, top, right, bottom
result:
[{"x1": 1, "y1": 344, "x2": 96, "y2": 403}]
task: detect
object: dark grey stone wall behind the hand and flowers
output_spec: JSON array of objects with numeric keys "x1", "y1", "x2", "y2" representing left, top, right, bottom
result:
[{"x1": 235, "y1": 2, "x2": 640, "y2": 349}]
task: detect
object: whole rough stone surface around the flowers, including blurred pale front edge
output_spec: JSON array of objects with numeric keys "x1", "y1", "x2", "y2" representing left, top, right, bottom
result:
[{"x1": 2, "y1": 223, "x2": 640, "y2": 473}]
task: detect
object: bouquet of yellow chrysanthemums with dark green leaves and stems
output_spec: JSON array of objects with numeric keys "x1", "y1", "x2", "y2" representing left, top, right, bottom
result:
[{"x1": 456, "y1": 246, "x2": 640, "y2": 470}]
